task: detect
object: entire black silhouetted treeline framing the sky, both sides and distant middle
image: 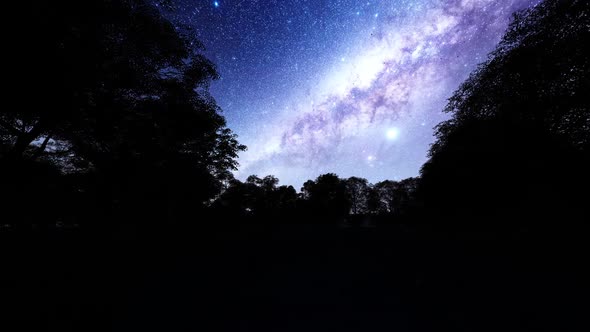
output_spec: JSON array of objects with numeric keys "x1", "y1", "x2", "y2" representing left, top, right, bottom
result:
[{"x1": 0, "y1": 0, "x2": 590, "y2": 233}]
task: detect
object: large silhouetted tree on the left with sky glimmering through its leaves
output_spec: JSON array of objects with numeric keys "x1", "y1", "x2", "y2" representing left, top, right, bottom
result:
[{"x1": 0, "y1": 0, "x2": 245, "y2": 224}]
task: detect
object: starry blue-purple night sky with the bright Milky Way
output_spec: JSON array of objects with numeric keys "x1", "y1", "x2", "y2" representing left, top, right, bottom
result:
[{"x1": 168, "y1": 0, "x2": 538, "y2": 189}]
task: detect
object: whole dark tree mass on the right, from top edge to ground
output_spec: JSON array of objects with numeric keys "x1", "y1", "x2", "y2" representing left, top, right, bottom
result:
[{"x1": 419, "y1": 0, "x2": 590, "y2": 223}]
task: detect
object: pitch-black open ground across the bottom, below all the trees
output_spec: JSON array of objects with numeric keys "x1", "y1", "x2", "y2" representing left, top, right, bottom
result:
[{"x1": 0, "y1": 225, "x2": 590, "y2": 332}]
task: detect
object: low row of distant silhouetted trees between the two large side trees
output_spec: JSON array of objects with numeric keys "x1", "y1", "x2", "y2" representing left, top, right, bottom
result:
[{"x1": 211, "y1": 173, "x2": 418, "y2": 222}]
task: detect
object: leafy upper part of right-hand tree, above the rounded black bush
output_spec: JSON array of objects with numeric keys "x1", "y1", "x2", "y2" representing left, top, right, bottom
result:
[{"x1": 431, "y1": 0, "x2": 590, "y2": 154}]
